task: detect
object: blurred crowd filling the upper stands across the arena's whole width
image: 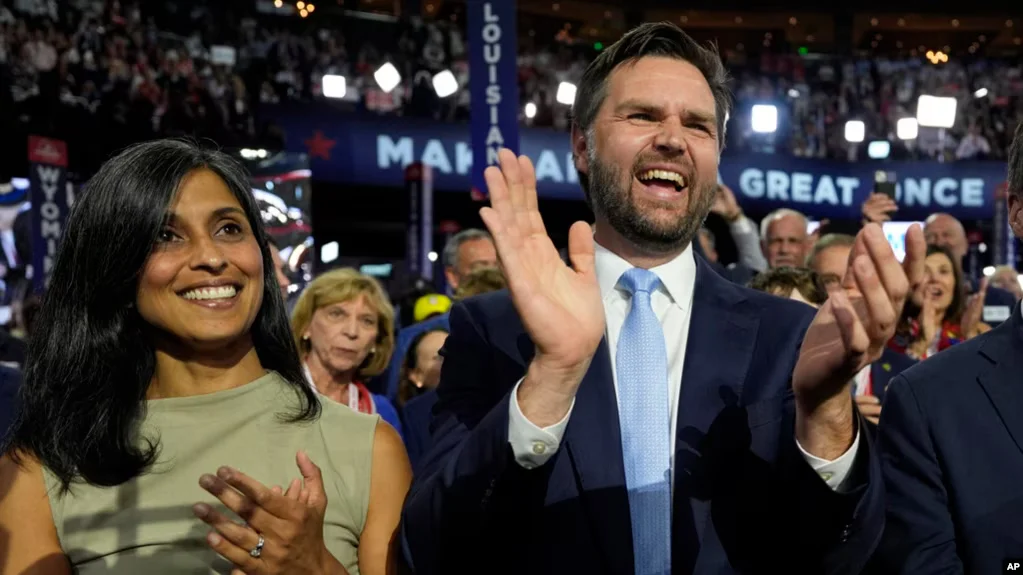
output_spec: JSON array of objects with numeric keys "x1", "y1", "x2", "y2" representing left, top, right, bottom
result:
[{"x1": 0, "y1": 0, "x2": 1023, "y2": 178}]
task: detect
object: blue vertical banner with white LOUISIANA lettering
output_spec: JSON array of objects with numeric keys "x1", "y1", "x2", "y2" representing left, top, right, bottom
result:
[{"x1": 466, "y1": 0, "x2": 519, "y2": 196}]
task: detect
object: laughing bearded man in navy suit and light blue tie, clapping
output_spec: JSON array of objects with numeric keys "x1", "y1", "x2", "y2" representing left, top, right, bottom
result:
[{"x1": 403, "y1": 24, "x2": 924, "y2": 575}]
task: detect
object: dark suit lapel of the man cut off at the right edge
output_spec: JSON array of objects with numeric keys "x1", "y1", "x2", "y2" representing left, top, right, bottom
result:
[{"x1": 978, "y1": 304, "x2": 1023, "y2": 451}]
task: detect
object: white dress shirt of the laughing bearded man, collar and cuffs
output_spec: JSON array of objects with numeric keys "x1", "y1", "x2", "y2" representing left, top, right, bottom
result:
[{"x1": 508, "y1": 240, "x2": 859, "y2": 489}]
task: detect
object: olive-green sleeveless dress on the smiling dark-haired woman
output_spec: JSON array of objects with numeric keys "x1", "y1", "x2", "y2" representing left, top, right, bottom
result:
[{"x1": 44, "y1": 372, "x2": 380, "y2": 575}]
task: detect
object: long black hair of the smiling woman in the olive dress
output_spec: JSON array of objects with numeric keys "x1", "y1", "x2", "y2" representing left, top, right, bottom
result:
[{"x1": 3, "y1": 140, "x2": 320, "y2": 490}]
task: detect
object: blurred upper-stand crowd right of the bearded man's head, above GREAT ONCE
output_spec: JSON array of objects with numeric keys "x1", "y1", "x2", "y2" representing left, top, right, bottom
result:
[{"x1": 729, "y1": 54, "x2": 1023, "y2": 162}]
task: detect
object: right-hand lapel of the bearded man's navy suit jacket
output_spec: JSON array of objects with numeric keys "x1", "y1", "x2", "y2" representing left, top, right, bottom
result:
[{"x1": 672, "y1": 258, "x2": 759, "y2": 573}]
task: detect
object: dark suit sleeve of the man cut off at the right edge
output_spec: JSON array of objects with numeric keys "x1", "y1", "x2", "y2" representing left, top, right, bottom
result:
[{"x1": 878, "y1": 375, "x2": 964, "y2": 575}]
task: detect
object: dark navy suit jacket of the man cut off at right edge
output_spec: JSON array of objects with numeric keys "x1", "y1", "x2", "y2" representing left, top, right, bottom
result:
[{"x1": 877, "y1": 306, "x2": 1023, "y2": 575}]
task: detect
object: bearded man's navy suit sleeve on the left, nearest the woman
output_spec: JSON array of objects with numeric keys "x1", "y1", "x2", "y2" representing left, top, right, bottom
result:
[{"x1": 402, "y1": 304, "x2": 561, "y2": 574}]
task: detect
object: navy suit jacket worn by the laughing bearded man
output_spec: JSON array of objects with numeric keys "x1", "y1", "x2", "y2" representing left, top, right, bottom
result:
[{"x1": 402, "y1": 258, "x2": 884, "y2": 575}]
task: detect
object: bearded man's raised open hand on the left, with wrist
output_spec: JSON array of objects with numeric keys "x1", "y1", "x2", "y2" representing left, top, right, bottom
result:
[{"x1": 480, "y1": 149, "x2": 604, "y2": 427}]
